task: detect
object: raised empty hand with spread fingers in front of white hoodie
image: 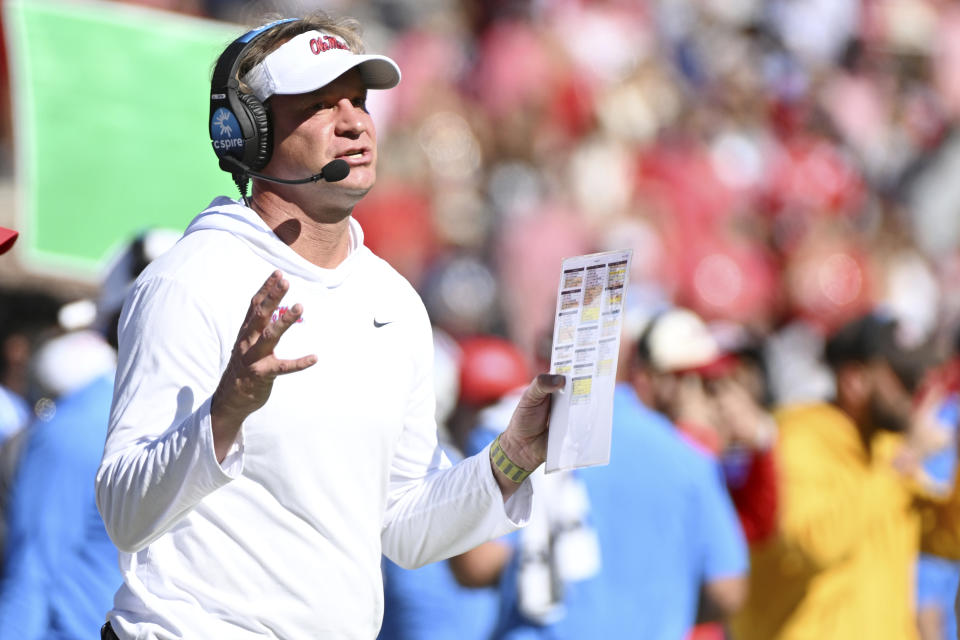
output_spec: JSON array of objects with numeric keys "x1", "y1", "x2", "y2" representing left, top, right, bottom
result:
[{"x1": 210, "y1": 271, "x2": 317, "y2": 462}]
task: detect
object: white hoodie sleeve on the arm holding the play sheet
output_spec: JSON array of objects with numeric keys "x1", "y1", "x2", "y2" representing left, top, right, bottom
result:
[{"x1": 381, "y1": 305, "x2": 533, "y2": 568}]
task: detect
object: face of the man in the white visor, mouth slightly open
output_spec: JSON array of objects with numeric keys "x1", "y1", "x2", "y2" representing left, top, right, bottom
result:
[{"x1": 264, "y1": 69, "x2": 377, "y2": 198}]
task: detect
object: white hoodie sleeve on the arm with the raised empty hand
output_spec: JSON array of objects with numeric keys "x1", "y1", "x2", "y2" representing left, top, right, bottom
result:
[{"x1": 96, "y1": 277, "x2": 243, "y2": 552}]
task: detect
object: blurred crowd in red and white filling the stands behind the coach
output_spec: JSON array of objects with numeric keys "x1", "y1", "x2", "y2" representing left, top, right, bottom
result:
[{"x1": 0, "y1": 0, "x2": 960, "y2": 640}]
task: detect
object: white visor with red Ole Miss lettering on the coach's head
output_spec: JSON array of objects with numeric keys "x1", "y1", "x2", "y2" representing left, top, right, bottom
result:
[{"x1": 243, "y1": 30, "x2": 400, "y2": 101}]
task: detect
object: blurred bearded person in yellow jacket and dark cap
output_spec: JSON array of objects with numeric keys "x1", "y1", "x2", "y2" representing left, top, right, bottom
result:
[{"x1": 732, "y1": 315, "x2": 960, "y2": 640}]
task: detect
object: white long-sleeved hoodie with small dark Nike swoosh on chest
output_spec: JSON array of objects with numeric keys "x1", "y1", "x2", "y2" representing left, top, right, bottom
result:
[{"x1": 97, "y1": 198, "x2": 531, "y2": 640}]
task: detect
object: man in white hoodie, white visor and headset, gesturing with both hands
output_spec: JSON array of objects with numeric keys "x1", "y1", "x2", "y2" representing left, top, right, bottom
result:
[{"x1": 97, "y1": 15, "x2": 564, "y2": 640}]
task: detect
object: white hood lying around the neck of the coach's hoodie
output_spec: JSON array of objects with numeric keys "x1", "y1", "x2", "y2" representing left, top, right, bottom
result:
[{"x1": 184, "y1": 196, "x2": 369, "y2": 288}]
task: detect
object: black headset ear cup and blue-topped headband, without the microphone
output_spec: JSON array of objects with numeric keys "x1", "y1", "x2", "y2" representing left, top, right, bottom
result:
[{"x1": 210, "y1": 18, "x2": 299, "y2": 195}]
